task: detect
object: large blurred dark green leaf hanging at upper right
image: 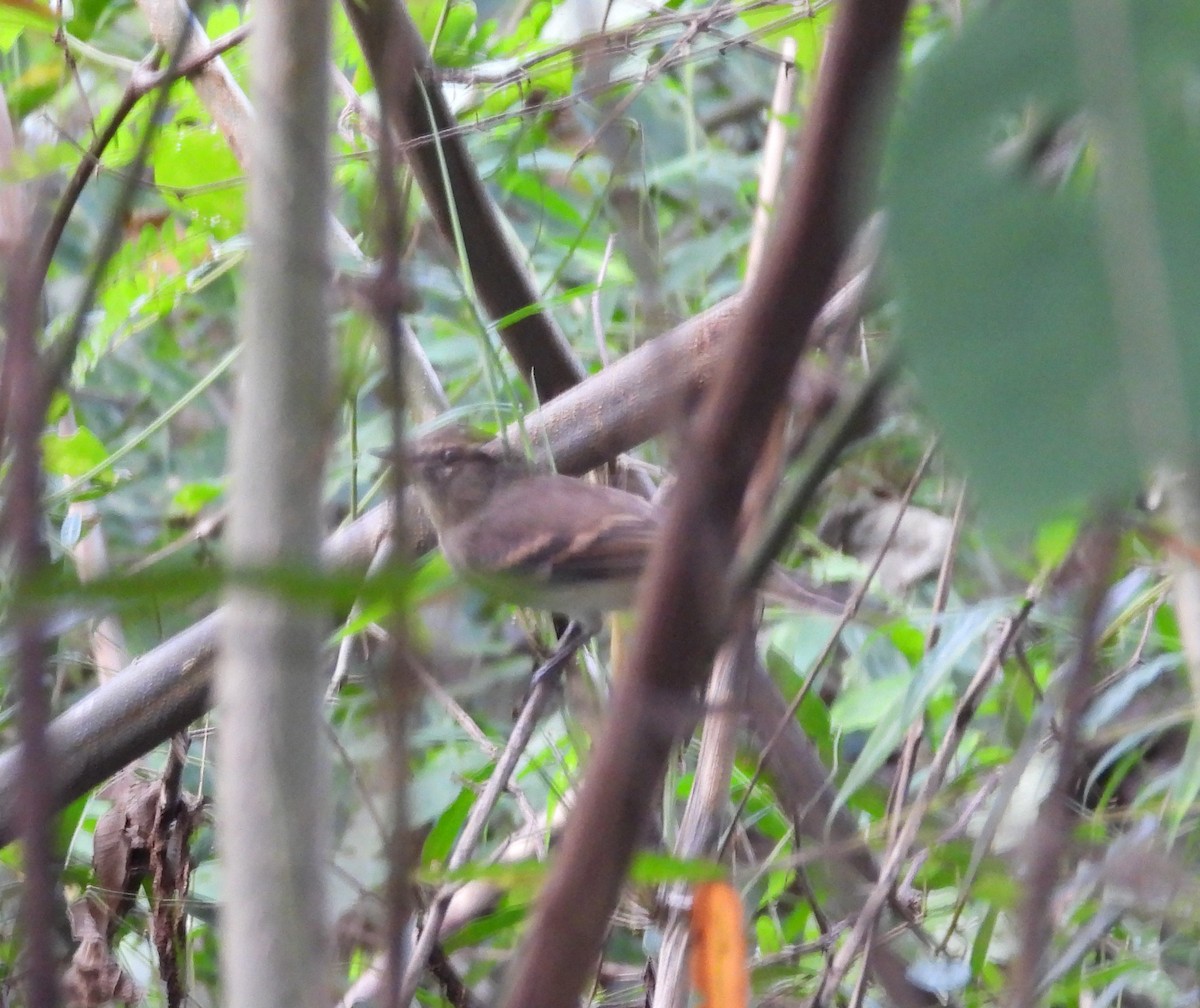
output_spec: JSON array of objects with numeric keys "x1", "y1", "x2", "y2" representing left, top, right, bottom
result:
[{"x1": 887, "y1": 0, "x2": 1200, "y2": 526}]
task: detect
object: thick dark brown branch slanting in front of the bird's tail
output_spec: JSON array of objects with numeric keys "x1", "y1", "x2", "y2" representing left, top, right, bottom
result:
[{"x1": 496, "y1": 0, "x2": 907, "y2": 1008}]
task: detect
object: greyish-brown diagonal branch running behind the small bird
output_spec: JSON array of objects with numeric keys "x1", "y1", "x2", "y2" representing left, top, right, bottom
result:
[{"x1": 0, "y1": 255, "x2": 858, "y2": 846}]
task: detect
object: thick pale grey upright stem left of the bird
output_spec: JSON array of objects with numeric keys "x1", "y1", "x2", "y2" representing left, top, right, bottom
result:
[{"x1": 216, "y1": 0, "x2": 335, "y2": 1008}]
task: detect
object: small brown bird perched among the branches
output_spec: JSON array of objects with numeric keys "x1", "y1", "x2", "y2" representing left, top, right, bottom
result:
[{"x1": 408, "y1": 431, "x2": 844, "y2": 632}]
